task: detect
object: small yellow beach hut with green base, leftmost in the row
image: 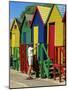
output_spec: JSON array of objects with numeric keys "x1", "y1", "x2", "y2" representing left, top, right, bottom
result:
[{"x1": 10, "y1": 18, "x2": 21, "y2": 70}]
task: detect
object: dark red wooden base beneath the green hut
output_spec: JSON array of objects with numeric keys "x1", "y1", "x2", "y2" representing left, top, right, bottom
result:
[{"x1": 20, "y1": 44, "x2": 28, "y2": 73}]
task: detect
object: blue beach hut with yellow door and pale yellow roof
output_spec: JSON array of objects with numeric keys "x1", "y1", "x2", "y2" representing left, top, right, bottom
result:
[{"x1": 31, "y1": 6, "x2": 52, "y2": 77}]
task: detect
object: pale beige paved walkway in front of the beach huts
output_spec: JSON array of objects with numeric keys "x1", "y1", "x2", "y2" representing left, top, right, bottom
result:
[{"x1": 10, "y1": 70, "x2": 65, "y2": 88}]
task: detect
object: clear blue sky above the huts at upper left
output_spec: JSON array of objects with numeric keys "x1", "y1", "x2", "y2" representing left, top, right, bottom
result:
[{"x1": 9, "y1": 1, "x2": 33, "y2": 22}]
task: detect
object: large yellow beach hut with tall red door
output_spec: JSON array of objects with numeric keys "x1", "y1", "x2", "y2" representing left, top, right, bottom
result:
[{"x1": 47, "y1": 5, "x2": 65, "y2": 64}]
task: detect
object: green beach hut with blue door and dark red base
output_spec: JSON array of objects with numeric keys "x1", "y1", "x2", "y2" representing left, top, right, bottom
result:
[{"x1": 20, "y1": 14, "x2": 33, "y2": 73}]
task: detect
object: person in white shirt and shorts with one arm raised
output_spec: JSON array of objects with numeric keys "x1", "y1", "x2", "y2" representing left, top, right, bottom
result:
[{"x1": 27, "y1": 44, "x2": 39, "y2": 80}]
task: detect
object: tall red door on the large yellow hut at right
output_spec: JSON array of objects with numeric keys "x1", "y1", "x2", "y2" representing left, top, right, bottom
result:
[{"x1": 48, "y1": 23, "x2": 55, "y2": 61}]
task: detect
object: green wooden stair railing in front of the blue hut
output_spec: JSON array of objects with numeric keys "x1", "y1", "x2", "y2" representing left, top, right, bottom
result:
[{"x1": 40, "y1": 43, "x2": 52, "y2": 78}]
